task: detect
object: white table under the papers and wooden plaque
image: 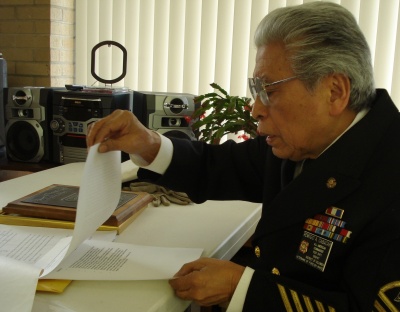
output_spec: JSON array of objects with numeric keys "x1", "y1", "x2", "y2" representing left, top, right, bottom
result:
[{"x1": 0, "y1": 163, "x2": 261, "y2": 312}]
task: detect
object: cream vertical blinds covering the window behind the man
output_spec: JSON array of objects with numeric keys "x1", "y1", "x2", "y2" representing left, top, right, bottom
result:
[{"x1": 76, "y1": 0, "x2": 400, "y2": 107}]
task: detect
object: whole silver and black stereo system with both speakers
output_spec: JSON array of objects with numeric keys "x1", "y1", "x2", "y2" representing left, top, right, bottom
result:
[{"x1": 5, "y1": 87, "x2": 199, "y2": 164}]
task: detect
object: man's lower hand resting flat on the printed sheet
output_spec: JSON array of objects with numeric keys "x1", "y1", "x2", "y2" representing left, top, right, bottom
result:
[{"x1": 169, "y1": 258, "x2": 245, "y2": 306}]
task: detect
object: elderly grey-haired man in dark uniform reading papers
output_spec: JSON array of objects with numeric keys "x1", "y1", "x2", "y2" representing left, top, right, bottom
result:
[{"x1": 87, "y1": 2, "x2": 400, "y2": 311}]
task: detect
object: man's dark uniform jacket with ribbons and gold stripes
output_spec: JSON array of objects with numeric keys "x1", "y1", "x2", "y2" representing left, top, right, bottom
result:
[{"x1": 139, "y1": 90, "x2": 400, "y2": 312}]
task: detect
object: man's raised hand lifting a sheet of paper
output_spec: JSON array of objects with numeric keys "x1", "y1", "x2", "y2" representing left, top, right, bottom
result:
[{"x1": 86, "y1": 110, "x2": 160, "y2": 165}]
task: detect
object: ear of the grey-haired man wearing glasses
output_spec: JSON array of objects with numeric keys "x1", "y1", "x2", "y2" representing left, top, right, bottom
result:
[{"x1": 328, "y1": 73, "x2": 350, "y2": 116}]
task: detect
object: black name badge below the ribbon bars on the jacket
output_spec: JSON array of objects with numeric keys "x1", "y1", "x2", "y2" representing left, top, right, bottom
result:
[{"x1": 296, "y1": 231, "x2": 333, "y2": 272}]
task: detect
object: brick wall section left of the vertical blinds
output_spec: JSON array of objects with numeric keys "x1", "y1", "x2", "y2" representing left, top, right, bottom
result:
[{"x1": 0, "y1": 0, "x2": 75, "y2": 87}]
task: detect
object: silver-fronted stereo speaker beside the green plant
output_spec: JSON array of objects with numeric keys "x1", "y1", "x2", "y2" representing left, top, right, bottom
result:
[{"x1": 133, "y1": 92, "x2": 200, "y2": 141}]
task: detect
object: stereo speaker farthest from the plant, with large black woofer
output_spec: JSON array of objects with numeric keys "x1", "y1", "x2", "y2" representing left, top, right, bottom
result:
[{"x1": 5, "y1": 87, "x2": 59, "y2": 163}]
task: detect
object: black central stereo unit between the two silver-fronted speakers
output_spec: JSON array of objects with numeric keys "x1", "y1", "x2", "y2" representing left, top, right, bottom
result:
[{"x1": 50, "y1": 88, "x2": 133, "y2": 164}]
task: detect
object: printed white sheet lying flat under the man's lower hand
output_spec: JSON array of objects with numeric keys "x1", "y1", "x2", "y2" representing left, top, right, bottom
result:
[{"x1": 46, "y1": 240, "x2": 203, "y2": 280}]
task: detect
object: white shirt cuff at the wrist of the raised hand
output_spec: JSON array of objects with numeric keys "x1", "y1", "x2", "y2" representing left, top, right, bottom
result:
[{"x1": 129, "y1": 132, "x2": 174, "y2": 174}]
